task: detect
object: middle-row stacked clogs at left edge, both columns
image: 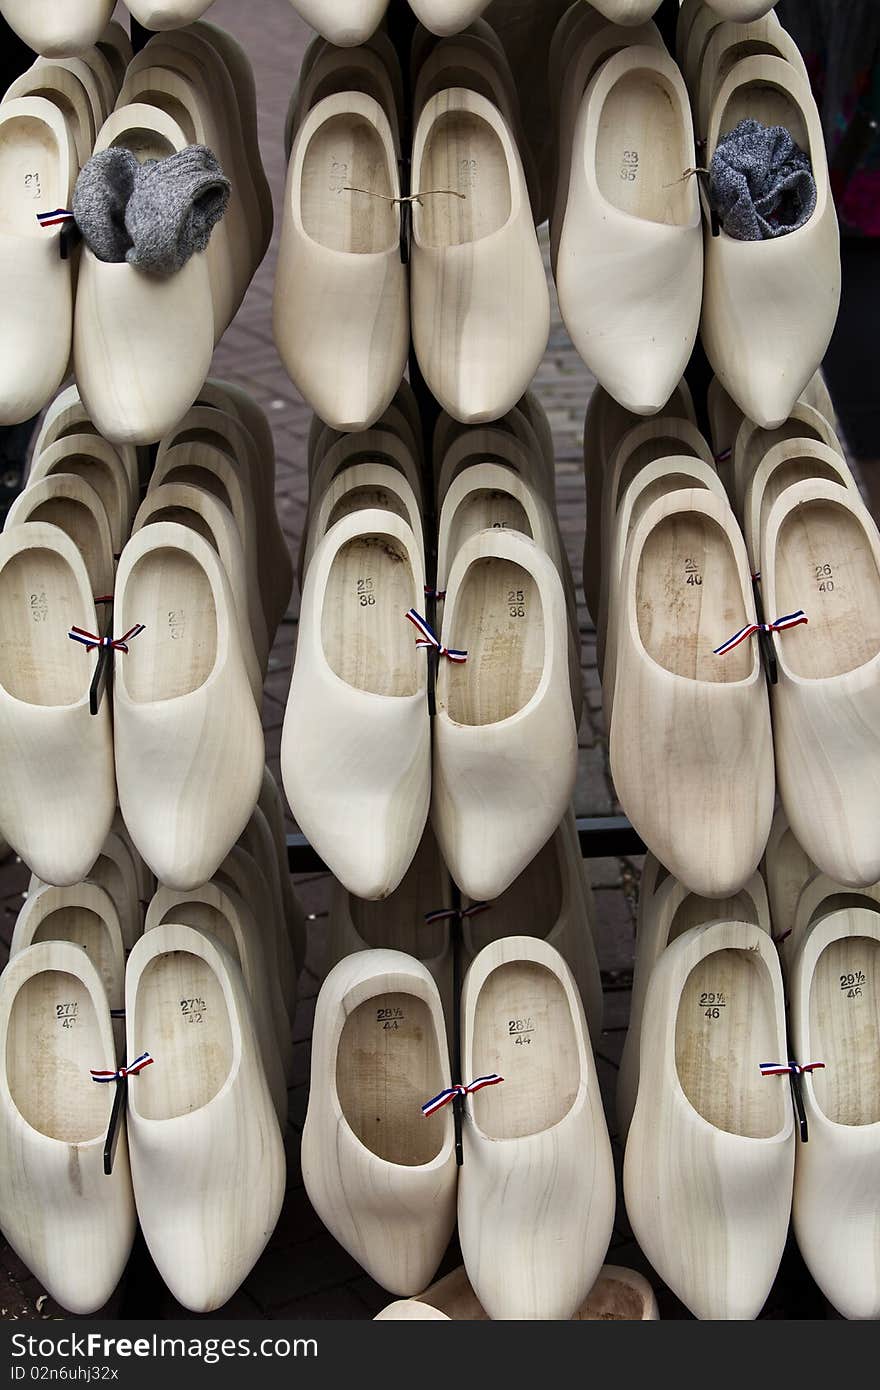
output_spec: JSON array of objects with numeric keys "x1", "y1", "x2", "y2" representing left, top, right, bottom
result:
[{"x1": 0, "y1": 381, "x2": 292, "y2": 888}]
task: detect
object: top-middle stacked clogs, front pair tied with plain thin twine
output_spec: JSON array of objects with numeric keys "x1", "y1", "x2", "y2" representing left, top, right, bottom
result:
[{"x1": 274, "y1": 26, "x2": 549, "y2": 431}]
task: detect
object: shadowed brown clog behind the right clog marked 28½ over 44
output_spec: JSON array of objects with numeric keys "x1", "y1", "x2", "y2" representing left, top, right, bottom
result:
[{"x1": 462, "y1": 810, "x2": 602, "y2": 1043}]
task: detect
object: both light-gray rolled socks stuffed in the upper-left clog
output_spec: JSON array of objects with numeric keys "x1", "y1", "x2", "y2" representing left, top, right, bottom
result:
[{"x1": 74, "y1": 145, "x2": 231, "y2": 275}]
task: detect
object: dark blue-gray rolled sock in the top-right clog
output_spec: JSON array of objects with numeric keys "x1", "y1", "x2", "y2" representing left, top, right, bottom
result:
[{"x1": 709, "y1": 120, "x2": 816, "y2": 242}]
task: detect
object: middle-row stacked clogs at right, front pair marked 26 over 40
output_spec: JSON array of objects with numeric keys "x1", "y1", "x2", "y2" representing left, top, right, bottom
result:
[{"x1": 584, "y1": 382, "x2": 880, "y2": 897}]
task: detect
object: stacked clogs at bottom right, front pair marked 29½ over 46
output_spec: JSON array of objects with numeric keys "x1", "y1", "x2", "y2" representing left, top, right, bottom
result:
[{"x1": 617, "y1": 813, "x2": 880, "y2": 1318}]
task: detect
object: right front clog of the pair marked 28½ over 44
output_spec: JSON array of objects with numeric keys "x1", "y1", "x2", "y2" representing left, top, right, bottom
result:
[{"x1": 459, "y1": 937, "x2": 614, "y2": 1319}]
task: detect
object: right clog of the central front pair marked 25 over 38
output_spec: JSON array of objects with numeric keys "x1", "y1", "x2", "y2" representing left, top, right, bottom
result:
[{"x1": 431, "y1": 530, "x2": 577, "y2": 901}]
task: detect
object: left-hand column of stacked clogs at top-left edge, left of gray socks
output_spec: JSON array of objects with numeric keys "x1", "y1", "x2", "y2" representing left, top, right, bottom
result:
[{"x1": 0, "y1": 20, "x2": 131, "y2": 424}]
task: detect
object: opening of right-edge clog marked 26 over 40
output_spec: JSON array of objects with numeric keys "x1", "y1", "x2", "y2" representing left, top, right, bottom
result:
[{"x1": 776, "y1": 498, "x2": 880, "y2": 680}]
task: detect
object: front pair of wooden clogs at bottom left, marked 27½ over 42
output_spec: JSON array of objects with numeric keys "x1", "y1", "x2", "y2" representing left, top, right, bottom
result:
[{"x1": 0, "y1": 922, "x2": 285, "y2": 1314}]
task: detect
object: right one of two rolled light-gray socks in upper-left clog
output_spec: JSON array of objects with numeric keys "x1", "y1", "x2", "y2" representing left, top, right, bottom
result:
[{"x1": 125, "y1": 145, "x2": 231, "y2": 275}]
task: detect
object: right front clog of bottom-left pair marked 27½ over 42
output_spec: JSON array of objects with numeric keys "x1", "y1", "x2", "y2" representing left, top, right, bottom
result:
[{"x1": 125, "y1": 923, "x2": 285, "y2": 1312}]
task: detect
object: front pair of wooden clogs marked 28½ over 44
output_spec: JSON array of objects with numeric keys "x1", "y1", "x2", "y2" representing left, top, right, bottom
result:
[{"x1": 302, "y1": 937, "x2": 614, "y2": 1319}]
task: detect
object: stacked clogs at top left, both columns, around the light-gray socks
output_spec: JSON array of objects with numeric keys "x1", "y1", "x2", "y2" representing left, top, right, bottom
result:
[{"x1": 0, "y1": 22, "x2": 272, "y2": 443}]
